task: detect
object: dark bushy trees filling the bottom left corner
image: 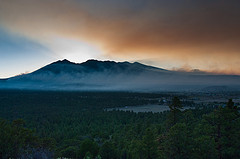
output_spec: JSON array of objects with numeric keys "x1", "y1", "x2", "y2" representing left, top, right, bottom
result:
[{"x1": 0, "y1": 119, "x2": 54, "y2": 159}]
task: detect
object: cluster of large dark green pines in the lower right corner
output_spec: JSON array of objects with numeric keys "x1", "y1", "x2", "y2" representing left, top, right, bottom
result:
[{"x1": 160, "y1": 99, "x2": 240, "y2": 159}]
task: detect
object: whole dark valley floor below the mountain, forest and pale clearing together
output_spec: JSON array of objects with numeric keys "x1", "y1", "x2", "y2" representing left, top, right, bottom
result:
[{"x1": 0, "y1": 90, "x2": 240, "y2": 159}]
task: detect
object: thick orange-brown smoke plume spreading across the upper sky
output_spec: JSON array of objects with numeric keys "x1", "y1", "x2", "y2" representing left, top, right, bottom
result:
[{"x1": 0, "y1": 0, "x2": 240, "y2": 74}]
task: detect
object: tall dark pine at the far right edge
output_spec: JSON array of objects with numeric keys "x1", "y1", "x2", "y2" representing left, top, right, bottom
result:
[{"x1": 203, "y1": 99, "x2": 240, "y2": 159}]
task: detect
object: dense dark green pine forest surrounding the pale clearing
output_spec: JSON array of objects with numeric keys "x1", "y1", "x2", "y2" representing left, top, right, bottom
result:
[{"x1": 0, "y1": 90, "x2": 240, "y2": 159}]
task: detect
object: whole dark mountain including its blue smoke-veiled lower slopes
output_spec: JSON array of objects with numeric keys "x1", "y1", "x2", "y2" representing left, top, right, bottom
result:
[{"x1": 0, "y1": 59, "x2": 240, "y2": 91}]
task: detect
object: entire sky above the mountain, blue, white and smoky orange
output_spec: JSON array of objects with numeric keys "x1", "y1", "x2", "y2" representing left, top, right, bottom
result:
[{"x1": 0, "y1": 0, "x2": 240, "y2": 78}]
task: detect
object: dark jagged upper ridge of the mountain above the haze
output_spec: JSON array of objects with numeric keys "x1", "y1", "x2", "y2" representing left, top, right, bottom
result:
[{"x1": 33, "y1": 59, "x2": 168, "y2": 74}]
